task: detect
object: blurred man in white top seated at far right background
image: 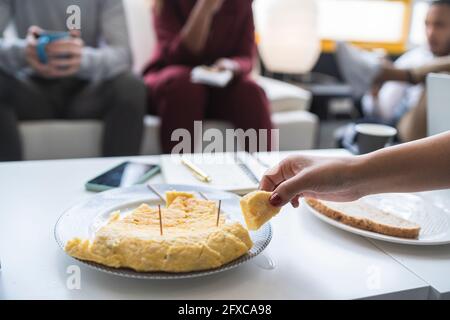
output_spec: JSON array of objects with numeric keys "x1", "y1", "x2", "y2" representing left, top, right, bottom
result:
[{"x1": 337, "y1": 0, "x2": 450, "y2": 142}]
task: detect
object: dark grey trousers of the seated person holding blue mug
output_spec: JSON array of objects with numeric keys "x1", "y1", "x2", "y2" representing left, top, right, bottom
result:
[{"x1": 0, "y1": 71, "x2": 146, "y2": 161}]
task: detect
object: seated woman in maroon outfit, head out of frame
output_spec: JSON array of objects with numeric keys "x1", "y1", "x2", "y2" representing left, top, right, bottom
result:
[{"x1": 145, "y1": 0, "x2": 272, "y2": 153}]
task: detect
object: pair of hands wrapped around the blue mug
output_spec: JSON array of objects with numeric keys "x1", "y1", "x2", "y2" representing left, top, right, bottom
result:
[{"x1": 25, "y1": 26, "x2": 84, "y2": 78}]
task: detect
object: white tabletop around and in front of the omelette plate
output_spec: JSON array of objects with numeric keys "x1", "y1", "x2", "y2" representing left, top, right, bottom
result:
[{"x1": 0, "y1": 153, "x2": 436, "y2": 299}]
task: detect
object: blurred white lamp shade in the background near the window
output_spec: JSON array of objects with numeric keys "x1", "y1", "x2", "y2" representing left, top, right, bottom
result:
[{"x1": 253, "y1": 0, "x2": 321, "y2": 74}]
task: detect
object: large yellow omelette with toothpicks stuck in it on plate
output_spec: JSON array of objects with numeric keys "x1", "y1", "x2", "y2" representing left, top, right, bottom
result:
[{"x1": 65, "y1": 191, "x2": 253, "y2": 272}]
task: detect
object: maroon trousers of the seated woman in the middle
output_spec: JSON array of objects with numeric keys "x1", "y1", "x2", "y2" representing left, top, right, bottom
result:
[{"x1": 144, "y1": 65, "x2": 273, "y2": 153}]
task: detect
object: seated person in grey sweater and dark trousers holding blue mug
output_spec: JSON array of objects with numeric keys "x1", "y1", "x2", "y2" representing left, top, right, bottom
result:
[{"x1": 0, "y1": 0, "x2": 146, "y2": 160}]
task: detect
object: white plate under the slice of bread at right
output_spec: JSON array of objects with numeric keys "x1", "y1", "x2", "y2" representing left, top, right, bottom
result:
[{"x1": 303, "y1": 194, "x2": 450, "y2": 245}]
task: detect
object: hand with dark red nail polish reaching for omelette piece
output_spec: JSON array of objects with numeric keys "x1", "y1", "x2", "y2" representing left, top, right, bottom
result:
[{"x1": 260, "y1": 156, "x2": 363, "y2": 208}]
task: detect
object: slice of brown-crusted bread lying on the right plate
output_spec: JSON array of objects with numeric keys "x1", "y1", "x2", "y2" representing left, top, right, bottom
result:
[{"x1": 306, "y1": 198, "x2": 420, "y2": 239}]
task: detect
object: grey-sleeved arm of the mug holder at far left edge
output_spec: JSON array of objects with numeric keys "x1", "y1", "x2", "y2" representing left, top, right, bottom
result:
[{"x1": 0, "y1": 0, "x2": 27, "y2": 73}]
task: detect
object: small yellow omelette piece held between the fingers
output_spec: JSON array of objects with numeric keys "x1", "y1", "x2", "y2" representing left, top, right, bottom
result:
[{"x1": 241, "y1": 191, "x2": 280, "y2": 230}]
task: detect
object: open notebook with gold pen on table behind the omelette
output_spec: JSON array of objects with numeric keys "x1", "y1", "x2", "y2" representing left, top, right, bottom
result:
[{"x1": 160, "y1": 152, "x2": 267, "y2": 195}]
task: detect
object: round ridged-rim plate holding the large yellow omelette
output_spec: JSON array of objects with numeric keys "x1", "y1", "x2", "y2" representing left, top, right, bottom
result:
[{"x1": 54, "y1": 184, "x2": 272, "y2": 279}]
